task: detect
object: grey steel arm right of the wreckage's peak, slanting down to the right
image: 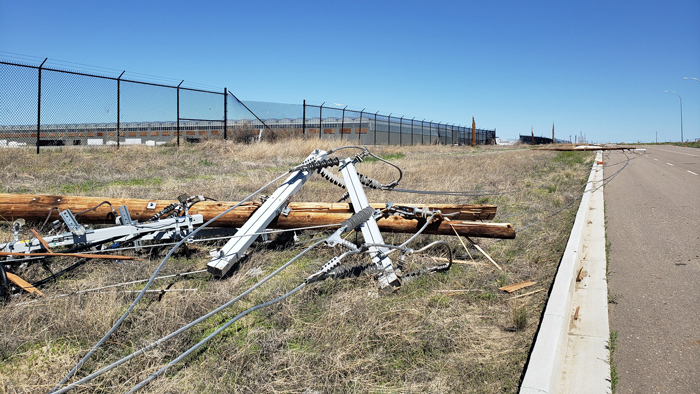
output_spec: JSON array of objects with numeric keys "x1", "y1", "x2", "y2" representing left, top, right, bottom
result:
[{"x1": 340, "y1": 158, "x2": 399, "y2": 289}]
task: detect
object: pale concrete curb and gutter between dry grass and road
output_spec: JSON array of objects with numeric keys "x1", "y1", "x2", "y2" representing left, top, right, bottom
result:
[{"x1": 520, "y1": 151, "x2": 611, "y2": 394}]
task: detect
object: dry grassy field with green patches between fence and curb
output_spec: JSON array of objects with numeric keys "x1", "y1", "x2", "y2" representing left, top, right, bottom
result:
[{"x1": 0, "y1": 140, "x2": 593, "y2": 394}]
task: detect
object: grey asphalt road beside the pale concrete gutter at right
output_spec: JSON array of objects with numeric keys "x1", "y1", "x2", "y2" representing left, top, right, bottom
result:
[{"x1": 605, "y1": 145, "x2": 700, "y2": 394}]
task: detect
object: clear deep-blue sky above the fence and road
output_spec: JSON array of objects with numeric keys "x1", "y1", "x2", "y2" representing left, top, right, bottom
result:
[{"x1": 0, "y1": 0, "x2": 700, "y2": 142}]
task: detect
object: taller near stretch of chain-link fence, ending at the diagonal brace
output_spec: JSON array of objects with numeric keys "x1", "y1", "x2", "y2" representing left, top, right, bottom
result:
[{"x1": 0, "y1": 61, "x2": 257, "y2": 152}]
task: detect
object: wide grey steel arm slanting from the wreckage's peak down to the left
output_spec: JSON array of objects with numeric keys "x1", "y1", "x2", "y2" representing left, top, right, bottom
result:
[{"x1": 207, "y1": 149, "x2": 327, "y2": 276}]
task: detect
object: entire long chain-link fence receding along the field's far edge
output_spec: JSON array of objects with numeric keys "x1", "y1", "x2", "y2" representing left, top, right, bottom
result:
[{"x1": 0, "y1": 59, "x2": 496, "y2": 153}]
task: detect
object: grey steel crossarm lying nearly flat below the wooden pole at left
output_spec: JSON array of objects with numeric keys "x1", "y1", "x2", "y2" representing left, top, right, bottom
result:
[{"x1": 0, "y1": 214, "x2": 204, "y2": 253}]
